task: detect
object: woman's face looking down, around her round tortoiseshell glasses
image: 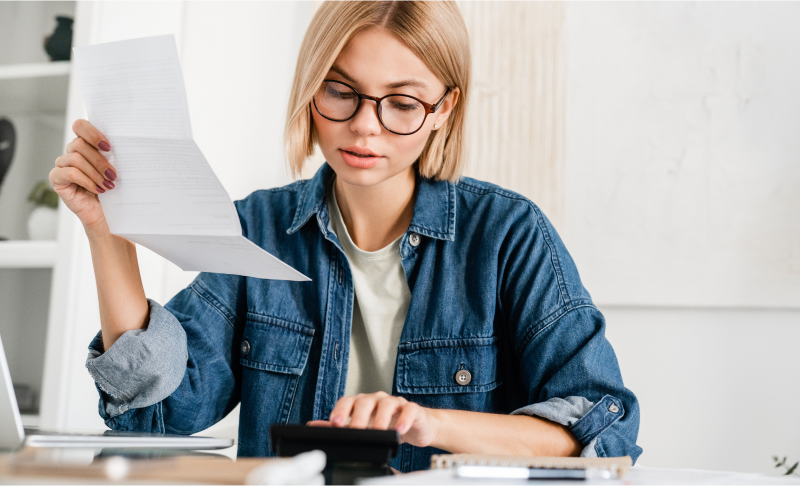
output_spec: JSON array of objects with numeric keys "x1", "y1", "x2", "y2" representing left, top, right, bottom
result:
[{"x1": 311, "y1": 28, "x2": 458, "y2": 186}]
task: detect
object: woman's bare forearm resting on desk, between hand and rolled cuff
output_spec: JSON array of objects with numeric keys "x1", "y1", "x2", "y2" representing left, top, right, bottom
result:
[{"x1": 428, "y1": 409, "x2": 582, "y2": 456}]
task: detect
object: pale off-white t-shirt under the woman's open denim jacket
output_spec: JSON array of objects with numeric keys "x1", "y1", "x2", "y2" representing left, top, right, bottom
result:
[{"x1": 327, "y1": 185, "x2": 411, "y2": 395}]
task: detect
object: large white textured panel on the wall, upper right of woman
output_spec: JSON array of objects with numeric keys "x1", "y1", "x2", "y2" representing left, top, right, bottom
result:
[{"x1": 565, "y1": 0, "x2": 800, "y2": 308}]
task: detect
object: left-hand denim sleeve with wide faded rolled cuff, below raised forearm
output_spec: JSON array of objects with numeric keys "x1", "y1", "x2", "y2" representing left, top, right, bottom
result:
[{"x1": 87, "y1": 273, "x2": 246, "y2": 435}]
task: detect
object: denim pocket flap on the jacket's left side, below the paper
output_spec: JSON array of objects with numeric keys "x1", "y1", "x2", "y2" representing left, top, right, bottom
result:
[{"x1": 239, "y1": 312, "x2": 314, "y2": 375}]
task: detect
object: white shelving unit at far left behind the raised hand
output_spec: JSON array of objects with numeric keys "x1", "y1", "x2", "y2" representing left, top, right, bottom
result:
[{"x1": 0, "y1": 0, "x2": 76, "y2": 425}]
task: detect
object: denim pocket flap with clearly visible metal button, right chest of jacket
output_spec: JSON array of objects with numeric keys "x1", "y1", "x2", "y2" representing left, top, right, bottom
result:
[{"x1": 397, "y1": 337, "x2": 500, "y2": 395}]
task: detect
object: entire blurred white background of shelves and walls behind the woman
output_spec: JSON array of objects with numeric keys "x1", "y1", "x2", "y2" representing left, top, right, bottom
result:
[{"x1": 0, "y1": 0, "x2": 800, "y2": 474}]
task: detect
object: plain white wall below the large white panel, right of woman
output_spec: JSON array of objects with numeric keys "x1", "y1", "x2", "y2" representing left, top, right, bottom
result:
[{"x1": 601, "y1": 306, "x2": 800, "y2": 474}]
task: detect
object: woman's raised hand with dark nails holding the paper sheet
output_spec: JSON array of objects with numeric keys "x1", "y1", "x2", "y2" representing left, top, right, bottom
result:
[{"x1": 50, "y1": 120, "x2": 117, "y2": 231}]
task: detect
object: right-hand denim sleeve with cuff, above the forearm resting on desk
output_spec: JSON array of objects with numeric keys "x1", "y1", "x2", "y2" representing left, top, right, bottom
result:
[{"x1": 500, "y1": 204, "x2": 642, "y2": 461}]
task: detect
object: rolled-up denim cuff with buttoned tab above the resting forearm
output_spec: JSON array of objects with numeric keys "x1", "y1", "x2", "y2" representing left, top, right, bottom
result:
[{"x1": 511, "y1": 395, "x2": 625, "y2": 457}]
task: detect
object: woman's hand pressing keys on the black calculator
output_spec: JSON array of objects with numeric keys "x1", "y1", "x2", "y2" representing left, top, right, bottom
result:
[{"x1": 308, "y1": 392, "x2": 439, "y2": 447}]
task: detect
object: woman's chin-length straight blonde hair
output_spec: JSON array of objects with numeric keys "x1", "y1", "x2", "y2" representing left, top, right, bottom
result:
[{"x1": 285, "y1": 0, "x2": 470, "y2": 180}]
